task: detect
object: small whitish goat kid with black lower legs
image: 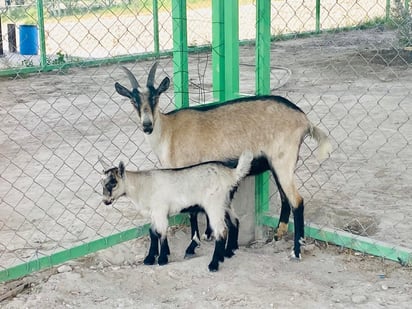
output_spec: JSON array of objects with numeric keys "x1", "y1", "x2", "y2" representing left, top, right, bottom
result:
[{"x1": 102, "y1": 151, "x2": 253, "y2": 271}]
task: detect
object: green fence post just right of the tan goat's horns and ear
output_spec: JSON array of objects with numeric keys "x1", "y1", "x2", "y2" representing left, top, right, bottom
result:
[{"x1": 172, "y1": 0, "x2": 189, "y2": 108}]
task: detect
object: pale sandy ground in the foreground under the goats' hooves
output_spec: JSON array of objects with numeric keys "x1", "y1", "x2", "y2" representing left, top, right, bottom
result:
[{"x1": 1, "y1": 225, "x2": 412, "y2": 309}]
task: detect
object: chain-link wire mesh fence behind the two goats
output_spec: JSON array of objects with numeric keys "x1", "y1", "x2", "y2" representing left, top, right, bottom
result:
[{"x1": 0, "y1": 0, "x2": 412, "y2": 282}]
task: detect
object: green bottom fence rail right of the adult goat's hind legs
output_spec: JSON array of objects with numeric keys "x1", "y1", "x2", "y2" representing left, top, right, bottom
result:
[{"x1": 262, "y1": 216, "x2": 412, "y2": 266}]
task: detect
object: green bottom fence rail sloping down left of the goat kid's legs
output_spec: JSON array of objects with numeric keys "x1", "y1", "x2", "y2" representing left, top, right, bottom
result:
[{"x1": 0, "y1": 215, "x2": 187, "y2": 282}]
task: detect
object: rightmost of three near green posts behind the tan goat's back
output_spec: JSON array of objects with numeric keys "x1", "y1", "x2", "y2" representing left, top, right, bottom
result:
[{"x1": 255, "y1": 0, "x2": 271, "y2": 236}]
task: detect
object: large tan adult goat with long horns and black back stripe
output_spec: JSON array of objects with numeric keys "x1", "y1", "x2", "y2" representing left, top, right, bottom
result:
[{"x1": 115, "y1": 62, "x2": 332, "y2": 258}]
